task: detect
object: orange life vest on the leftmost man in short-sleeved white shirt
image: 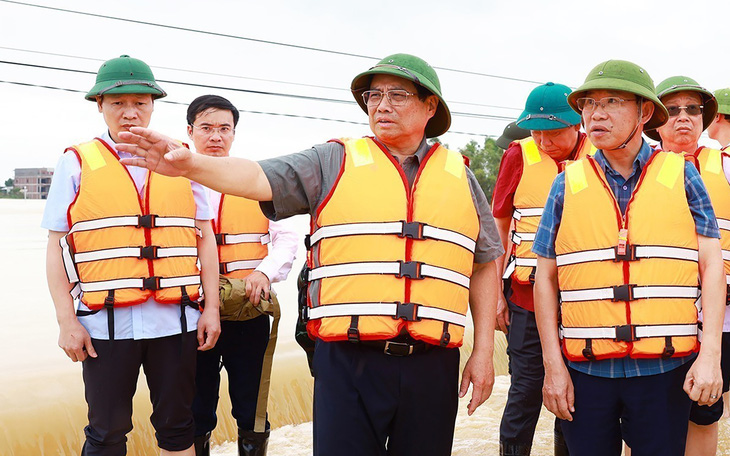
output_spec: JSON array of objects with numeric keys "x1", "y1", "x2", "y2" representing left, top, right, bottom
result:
[{"x1": 61, "y1": 139, "x2": 200, "y2": 310}]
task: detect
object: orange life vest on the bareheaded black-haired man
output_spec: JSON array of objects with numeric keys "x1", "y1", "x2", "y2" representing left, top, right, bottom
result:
[{"x1": 213, "y1": 195, "x2": 271, "y2": 279}]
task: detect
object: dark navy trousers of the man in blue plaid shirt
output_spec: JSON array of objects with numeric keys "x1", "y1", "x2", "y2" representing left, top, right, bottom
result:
[{"x1": 561, "y1": 362, "x2": 692, "y2": 456}]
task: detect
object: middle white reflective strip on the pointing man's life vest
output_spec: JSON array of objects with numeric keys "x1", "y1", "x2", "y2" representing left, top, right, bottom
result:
[{"x1": 309, "y1": 261, "x2": 469, "y2": 288}]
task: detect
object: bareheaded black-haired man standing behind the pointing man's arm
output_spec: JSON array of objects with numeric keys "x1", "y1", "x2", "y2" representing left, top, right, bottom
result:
[{"x1": 187, "y1": 95, "x2": 299, "y2": 456}]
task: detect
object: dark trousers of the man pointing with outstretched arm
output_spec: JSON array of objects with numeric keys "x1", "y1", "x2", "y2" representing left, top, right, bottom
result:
[{"x1": 314, "y1": 340, "x2": 459, "y2": 456}]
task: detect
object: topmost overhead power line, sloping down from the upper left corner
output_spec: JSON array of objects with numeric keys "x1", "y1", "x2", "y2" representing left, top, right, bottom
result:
[{"x1": 0, "y1": 0, "x2": 542, "y2": 85}]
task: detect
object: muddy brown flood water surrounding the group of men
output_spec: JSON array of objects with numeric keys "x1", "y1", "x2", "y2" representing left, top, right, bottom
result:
[{"x1": 0, "y1": 199, "x2": 730, "y2": 456}]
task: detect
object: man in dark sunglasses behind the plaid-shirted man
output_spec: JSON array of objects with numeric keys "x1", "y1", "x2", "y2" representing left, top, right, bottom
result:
[{"x1": 646, "y1": 76, "x2": 730, "y2": 456}]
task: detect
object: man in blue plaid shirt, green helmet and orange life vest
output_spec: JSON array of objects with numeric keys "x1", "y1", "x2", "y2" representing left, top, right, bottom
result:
[{"x1": 533, "y1": 60, "x2": 725, "y2": 456}]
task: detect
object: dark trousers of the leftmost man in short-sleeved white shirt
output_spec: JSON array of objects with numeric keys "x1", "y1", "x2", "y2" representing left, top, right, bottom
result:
[{"x1": 82, "y1": 331, "x2": 198, "y2": 456}]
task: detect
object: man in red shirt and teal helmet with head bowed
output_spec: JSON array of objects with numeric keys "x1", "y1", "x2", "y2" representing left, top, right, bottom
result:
[{"x1": 492, "y1": 82, "x2": 595, "y2": 456}]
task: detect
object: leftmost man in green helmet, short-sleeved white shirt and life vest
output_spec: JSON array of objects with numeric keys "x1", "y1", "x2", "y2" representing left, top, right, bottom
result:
[{"x1": 41, "y1": 55, "x2": 220, "y2": 456}]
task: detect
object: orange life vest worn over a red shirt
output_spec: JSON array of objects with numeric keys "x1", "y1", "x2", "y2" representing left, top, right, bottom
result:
[{"x1": 502, "y1": 137, "x2": 596, "y2": 284}]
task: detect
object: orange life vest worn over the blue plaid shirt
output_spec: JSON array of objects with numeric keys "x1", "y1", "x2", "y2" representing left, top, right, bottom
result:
[{"x1": 555, "y1": 152, "x2": 699, "y2": 361}]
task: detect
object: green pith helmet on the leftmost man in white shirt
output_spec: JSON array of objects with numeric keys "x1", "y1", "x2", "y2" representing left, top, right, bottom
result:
[{"x1": 85, "y1": 55, "x2": 167, "y2": 101}]
